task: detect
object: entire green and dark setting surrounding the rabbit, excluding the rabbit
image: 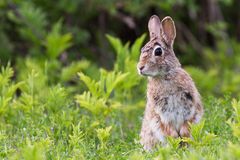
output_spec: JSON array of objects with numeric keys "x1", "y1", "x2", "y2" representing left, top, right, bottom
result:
[{"x1": 0, "y1": 0, "x2": 240, "y2": 160}]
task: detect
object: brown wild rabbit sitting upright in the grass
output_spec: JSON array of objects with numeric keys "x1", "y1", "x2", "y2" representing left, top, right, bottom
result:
[{"x1": 137, "y1": 15, "x2": 203, "y2": 151}]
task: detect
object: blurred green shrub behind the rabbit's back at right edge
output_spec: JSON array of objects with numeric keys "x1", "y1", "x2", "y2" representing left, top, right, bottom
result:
[{"x1": 186, "y1": 40, "x2": 240, "y2": 96}]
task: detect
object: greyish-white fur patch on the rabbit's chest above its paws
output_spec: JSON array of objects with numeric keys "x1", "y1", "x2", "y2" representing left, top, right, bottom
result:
[{"x1": 154, "y1": 92, "x2": 195, "y2": 129}]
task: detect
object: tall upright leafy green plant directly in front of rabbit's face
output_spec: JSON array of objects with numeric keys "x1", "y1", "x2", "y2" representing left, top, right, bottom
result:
[{"x1": 107, "y1": 34, "x2": 146, "y2": 101}]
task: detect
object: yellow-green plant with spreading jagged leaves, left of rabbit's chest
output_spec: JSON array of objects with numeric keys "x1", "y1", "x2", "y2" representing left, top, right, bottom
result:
[{"x1": 76, "y1": 69, "x2": 128, "y2": 114}]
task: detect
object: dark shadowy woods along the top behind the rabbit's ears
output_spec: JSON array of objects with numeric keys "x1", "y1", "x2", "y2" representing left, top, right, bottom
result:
[{"x1": 0, "y1": 0, "x2": 240, "y2": 68}]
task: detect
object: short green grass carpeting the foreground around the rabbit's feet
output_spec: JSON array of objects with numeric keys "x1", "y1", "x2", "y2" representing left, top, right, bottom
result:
[{"x1": 0, "y1": 63, "x2": 240, "y2": 160}]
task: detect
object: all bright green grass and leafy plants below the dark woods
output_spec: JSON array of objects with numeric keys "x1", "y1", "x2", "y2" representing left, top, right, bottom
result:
[{"x1": 0, "y1": 35, "x2": 240, "y2": 160}]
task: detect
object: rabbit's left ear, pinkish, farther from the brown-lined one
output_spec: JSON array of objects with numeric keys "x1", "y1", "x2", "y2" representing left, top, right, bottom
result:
[{"x1": 148, "y1": 15, "x2": 161, "y2": 39}]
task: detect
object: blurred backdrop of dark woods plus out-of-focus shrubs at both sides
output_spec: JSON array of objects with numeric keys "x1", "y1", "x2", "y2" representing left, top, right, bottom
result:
[{"x1": 0, "y1": 0, "x2": 240, "y2": 95}]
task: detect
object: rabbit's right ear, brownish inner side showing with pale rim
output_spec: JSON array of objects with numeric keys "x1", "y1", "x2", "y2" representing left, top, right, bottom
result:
[{"x1": 161, "y1": 16, "x2": 176, "y2": 46}]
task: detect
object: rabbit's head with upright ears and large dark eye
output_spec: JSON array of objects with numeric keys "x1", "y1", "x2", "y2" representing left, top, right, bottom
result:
[{"x1": 137, "y1": 15, "x2": 181, "y2": 77}]
